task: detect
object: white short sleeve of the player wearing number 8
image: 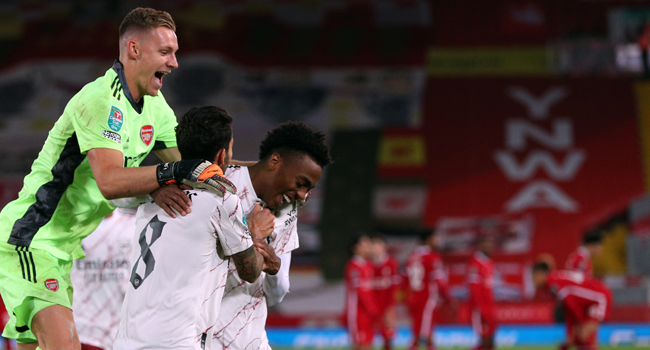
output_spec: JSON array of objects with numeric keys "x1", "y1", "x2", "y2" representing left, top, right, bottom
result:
[{"x1": 210, "y1": 193, "x2": 253, "y2": 256}]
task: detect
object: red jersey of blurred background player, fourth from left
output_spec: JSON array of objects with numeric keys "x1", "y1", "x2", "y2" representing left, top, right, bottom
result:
[{"x1": 467, "y1": 252, "x2": 494, "y2": 311}]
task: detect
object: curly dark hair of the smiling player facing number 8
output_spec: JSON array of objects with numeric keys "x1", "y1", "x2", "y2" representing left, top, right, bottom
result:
[{"x1": 260, "y1": 121, "x2": 332, "y2": 168}]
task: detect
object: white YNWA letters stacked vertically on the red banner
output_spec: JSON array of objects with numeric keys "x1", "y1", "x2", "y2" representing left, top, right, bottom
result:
[{"x1": 494, "y1": 87, "x2": 586, "y2": 212}]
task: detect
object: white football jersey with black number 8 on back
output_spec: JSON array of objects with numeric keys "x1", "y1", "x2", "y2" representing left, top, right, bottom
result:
[{"x1": 114, "y1": 190, "x2": 253, "y2": 350}]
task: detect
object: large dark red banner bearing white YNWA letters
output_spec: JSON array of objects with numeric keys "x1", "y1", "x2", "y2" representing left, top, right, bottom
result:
[{"x1": 423, "y1": 78, "x2": 644, "y2": 263}]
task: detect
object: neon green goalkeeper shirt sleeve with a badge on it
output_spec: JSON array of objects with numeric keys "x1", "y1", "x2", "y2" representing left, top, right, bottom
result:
[{"x1": 71, "y1": 89, "x2": 126, "y2": 154}]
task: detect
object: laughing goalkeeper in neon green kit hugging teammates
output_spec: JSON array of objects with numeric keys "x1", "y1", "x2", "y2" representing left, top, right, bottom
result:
[{"x1": 0, "y1": 8, "x2": 235, "y2": 350}]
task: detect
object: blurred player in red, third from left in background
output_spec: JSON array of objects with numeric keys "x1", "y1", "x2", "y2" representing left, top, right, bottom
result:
[{"x1": 405, "y1": 230, "x2": 456, "y2": 350}]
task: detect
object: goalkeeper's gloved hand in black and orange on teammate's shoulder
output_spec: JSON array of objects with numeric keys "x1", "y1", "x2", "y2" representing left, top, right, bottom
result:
[{"x1": 156, "y1": 159, "x2": 237, "y2": 196}]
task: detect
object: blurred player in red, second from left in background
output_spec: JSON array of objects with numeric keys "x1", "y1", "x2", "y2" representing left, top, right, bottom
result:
[{"x1": 371, "y1": 235, "x2": 401, "y2": 350}]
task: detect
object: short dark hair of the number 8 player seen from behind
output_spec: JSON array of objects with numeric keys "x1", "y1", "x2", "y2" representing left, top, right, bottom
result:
[{"x1": 176, "y1": 106, "x2": 232, "y2": 161}]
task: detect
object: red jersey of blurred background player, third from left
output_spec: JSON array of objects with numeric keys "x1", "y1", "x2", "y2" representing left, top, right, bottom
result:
[{"x1": 406, "y1": 246, "x2": 451, "y2": 304}]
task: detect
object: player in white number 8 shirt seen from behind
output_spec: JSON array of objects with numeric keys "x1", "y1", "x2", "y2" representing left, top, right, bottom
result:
[{"x1": 114, "y1": 106, "x2": 275, "y2": 350}]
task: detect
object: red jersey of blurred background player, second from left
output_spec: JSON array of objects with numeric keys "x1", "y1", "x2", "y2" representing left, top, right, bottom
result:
[{"x1": 372, "y1": 254, "x2": 401, "y2": 310}]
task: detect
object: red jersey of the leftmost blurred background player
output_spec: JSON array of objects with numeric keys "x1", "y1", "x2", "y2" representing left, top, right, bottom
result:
[{"x1": 345, "y1": 255, "x2": 379, "y2": 319}]
